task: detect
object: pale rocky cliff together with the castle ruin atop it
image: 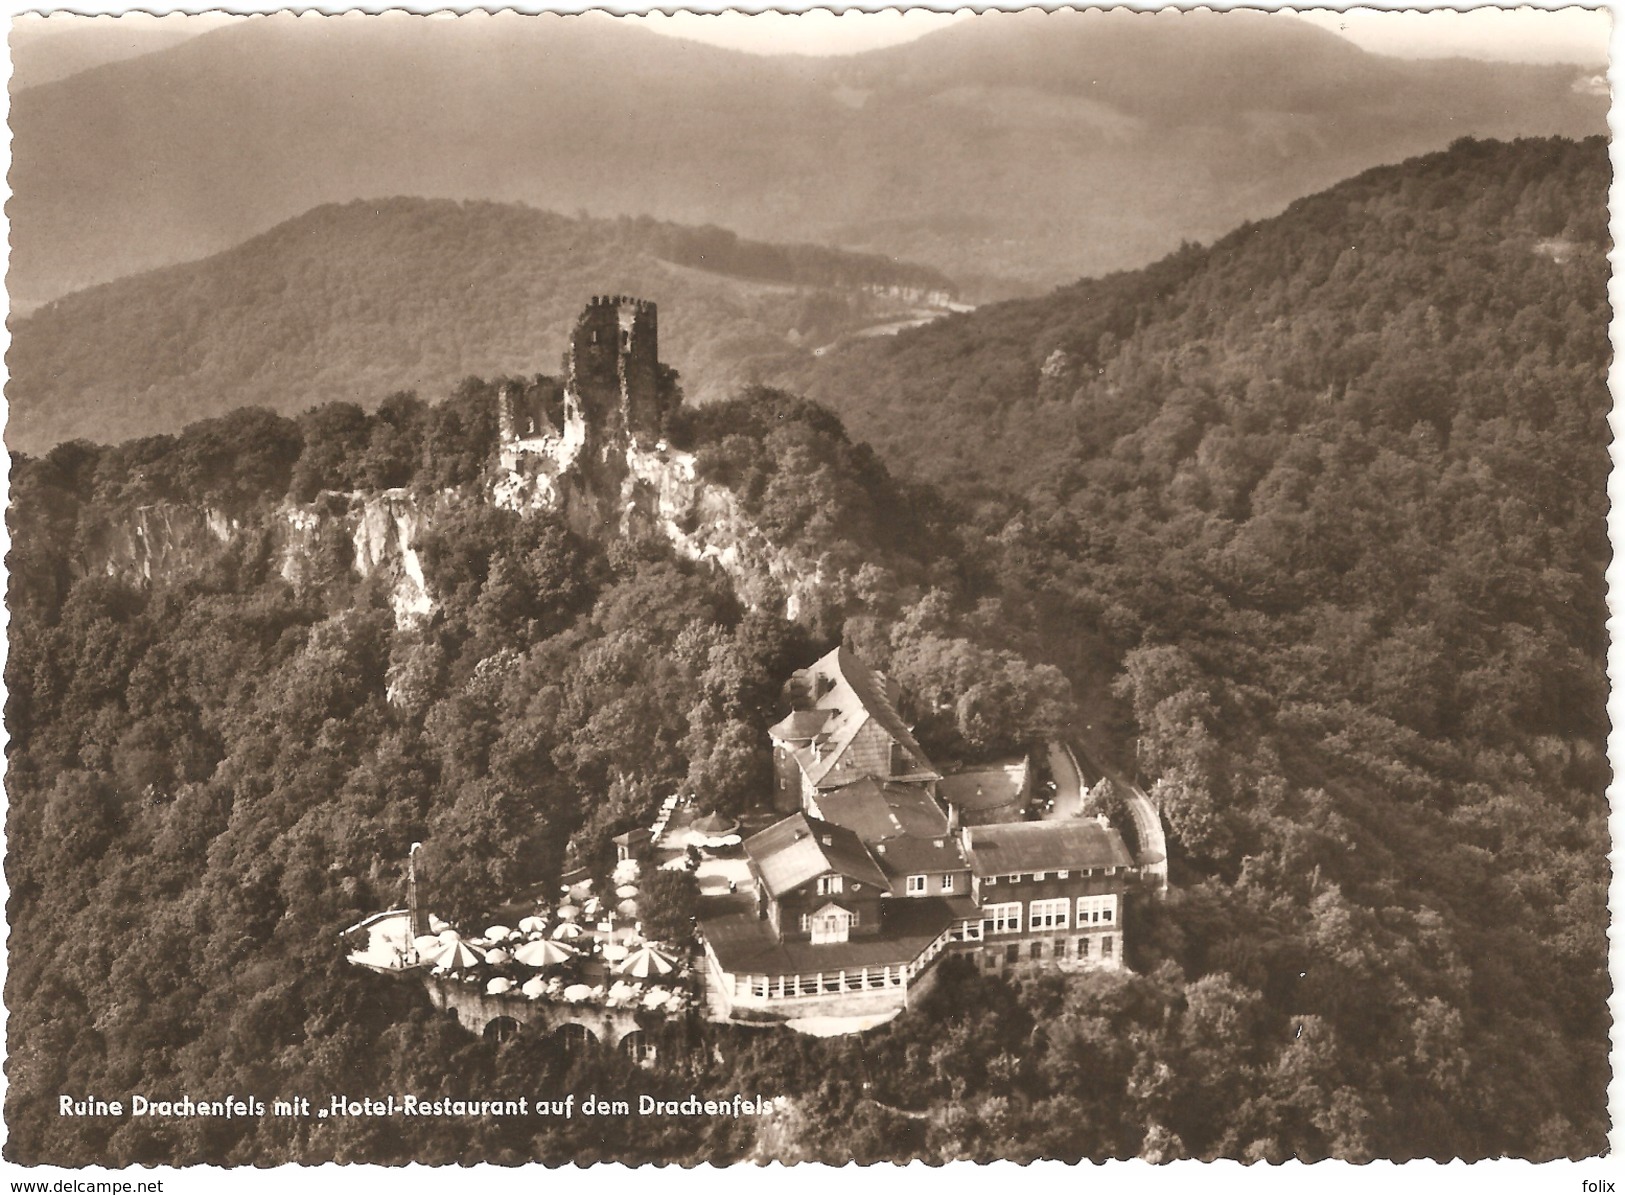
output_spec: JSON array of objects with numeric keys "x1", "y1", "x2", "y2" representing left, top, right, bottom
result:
[{"x1": 83, "y1": 296, "x2": 822, "y2": 626}]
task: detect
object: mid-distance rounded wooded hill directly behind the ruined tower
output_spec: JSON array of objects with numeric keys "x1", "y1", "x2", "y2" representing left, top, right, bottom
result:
[{"x1": 7, "y1": 198, "x2": 952, "y2": 450}]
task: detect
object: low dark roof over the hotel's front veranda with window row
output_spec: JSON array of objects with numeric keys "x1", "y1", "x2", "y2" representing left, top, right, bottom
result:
[{"x1": 700, "y1": 897, "x2": 949, "y2": 976}]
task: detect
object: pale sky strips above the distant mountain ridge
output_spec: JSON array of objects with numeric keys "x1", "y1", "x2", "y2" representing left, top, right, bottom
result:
[{"x1": 0, "y1": 0, "x2": 1610, "y2": 65}]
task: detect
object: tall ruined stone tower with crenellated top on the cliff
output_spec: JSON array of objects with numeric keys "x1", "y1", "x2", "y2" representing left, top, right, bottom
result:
[{"x1": 566, "y1": 294, "x2": 668, "y2": 445}]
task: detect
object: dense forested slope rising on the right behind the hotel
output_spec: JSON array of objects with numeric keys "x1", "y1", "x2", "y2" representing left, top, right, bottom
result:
[{"x1": 789, "y1": 140, "x2": 1610, "y2": 1156}]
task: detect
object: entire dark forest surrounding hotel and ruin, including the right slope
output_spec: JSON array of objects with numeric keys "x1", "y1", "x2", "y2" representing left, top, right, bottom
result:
[{"x1": 7, "y1": 141, "x2": 1610, "y2": 1164}]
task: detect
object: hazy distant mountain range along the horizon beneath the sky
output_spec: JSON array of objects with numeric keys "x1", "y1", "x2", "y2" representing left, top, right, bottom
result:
[{"x1": 8, "y1": 10, "x2": 1607, "y2": 302}]
